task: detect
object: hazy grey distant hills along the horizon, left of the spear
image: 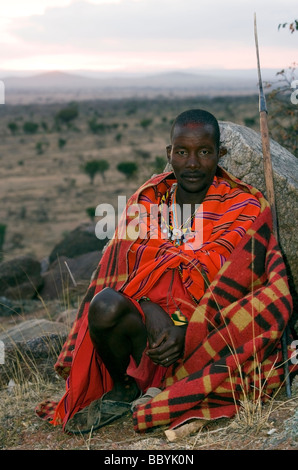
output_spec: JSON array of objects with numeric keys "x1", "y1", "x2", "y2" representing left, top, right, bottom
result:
[{"x1": 0, "y1": 71, "x2": 274, "y2": 103}]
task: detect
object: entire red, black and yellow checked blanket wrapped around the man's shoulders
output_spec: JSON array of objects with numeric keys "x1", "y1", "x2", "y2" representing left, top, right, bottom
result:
[{"x1": 37, "y1": 169, "x2": 292, "y2": 431}]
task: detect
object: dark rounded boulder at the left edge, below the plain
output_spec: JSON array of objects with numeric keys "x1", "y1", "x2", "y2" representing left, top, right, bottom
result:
[{"x1": 0, "y1": 255, "x2": 43, "y2": 299}]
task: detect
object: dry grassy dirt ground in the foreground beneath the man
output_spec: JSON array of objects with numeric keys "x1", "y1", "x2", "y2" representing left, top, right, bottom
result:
[{"x1": 0, "y1": 379, "x2": 298, "y2": 452}]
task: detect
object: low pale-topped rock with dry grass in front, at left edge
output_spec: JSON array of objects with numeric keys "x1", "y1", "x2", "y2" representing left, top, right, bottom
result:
[{"x1": 0, "y1": 319, "x2": 69, "y2": 385}]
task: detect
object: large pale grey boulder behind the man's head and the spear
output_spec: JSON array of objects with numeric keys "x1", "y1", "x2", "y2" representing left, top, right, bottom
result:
[{"x1": 166, "y1": 122, "x2": 298, "y2": 318}]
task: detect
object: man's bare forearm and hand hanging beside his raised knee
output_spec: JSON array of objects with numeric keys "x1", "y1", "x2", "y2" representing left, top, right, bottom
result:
[{"x1": 141, "y1": 301, "x2": 186, "y2": 367}]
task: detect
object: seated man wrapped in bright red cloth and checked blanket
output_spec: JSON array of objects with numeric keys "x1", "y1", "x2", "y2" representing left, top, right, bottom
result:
[{"x1": 39, "y1": 110, "x2": 292, "y2": 433}]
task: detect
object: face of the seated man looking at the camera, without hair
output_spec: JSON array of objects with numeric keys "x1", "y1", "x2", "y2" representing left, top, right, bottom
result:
[{"x1": 167, "y1": 123, "x2": 219, "y2": 197}]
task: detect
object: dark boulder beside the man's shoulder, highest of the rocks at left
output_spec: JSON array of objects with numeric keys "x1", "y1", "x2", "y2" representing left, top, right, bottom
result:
[{"x1": 49, "y1": 223, "x2": 107, "y2": 264}]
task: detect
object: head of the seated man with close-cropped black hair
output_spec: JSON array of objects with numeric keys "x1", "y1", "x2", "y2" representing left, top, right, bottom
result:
[{"x1": 167, "y1": 109, "x2": 223, "y2": 202}]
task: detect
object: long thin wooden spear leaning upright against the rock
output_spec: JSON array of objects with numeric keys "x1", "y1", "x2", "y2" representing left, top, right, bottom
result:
[{"x1": 254, "y1": 14, "x2": 291, "y2": 397}]
